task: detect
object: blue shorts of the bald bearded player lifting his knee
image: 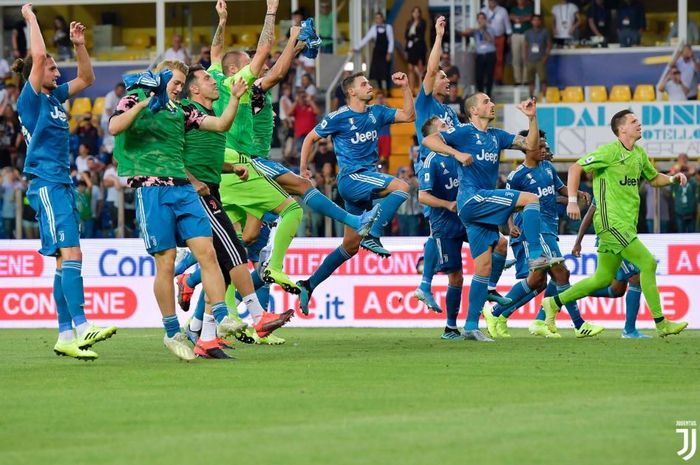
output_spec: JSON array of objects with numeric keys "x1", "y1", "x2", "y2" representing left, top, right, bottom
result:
[{"x1": 458, "y1": 189, "x2": 520, "y2": 258}]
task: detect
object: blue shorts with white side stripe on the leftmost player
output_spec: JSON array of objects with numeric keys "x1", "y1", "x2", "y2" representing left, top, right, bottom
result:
[{"x1": 27, "y1": 178, "x2": 80, "y2": 257}]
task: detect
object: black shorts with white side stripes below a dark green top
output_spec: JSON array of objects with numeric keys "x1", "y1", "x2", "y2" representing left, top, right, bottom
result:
[{"x1": 199, "y1": 184, "x2": 248, "y2": 284}]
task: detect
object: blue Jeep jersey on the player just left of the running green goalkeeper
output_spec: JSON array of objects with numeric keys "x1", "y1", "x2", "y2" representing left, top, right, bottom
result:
[{"x1": 506, "y1": 161, "x2": 564, "y2": 242}]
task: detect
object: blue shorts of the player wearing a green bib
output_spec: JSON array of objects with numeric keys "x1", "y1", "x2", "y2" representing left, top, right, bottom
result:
[{"x1": 136, "y1": 185, "x2": 212, "y2": 255}]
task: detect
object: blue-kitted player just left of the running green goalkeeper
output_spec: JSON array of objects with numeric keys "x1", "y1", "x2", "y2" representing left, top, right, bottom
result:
[{"x1": 484, "y1": 131, "x2": 603, "y2": 338}]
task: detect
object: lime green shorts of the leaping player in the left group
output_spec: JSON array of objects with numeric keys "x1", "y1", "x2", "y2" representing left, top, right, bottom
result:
[{"x1": 220, "y1": 149, "x2": 289, "y2": 224}]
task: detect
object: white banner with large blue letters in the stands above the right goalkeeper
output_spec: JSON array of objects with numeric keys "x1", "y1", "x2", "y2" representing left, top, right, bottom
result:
[{"x1": 504, "y1": 101, "x2": 700, "y2": 160}]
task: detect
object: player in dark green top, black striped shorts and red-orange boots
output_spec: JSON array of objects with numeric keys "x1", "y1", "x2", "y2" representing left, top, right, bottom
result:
[{"x1": 182, "y1": 66, "x2": 294, "y2": 358}]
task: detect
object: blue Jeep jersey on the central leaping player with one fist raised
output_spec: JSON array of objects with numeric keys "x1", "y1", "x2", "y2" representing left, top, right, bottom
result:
[{"x1": 314, "y1": 105, "x2": 396, "y2": 176}]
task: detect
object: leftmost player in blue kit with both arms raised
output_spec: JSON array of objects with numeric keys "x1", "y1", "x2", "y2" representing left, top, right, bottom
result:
[{"x1": 12, "y1": 3, "x2": 117, "y2": 360}]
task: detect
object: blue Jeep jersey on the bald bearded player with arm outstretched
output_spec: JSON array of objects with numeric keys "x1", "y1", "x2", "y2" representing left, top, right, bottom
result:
[{"x1": 440, "y1": 123, "x2": 515, "y2": 201}]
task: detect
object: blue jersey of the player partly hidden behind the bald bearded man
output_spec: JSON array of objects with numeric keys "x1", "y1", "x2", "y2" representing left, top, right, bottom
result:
[{"x1": 419, "y1": 152, "x2": 466, "y2": 238}]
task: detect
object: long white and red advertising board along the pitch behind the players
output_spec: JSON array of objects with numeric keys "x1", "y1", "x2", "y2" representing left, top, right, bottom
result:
[{"x1": 0, "y1": 234, "x2": 700, "y2": 329}]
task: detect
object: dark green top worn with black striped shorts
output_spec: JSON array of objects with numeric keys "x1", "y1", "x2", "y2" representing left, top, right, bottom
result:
[{"x1": 182, "y1": 100, "x2": 226, "y2": 185}]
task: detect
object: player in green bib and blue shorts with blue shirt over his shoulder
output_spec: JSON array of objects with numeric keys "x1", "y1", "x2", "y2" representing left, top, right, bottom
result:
[{"x1": 109, "y1": 60, "x2": 247, "y2": 360}]
